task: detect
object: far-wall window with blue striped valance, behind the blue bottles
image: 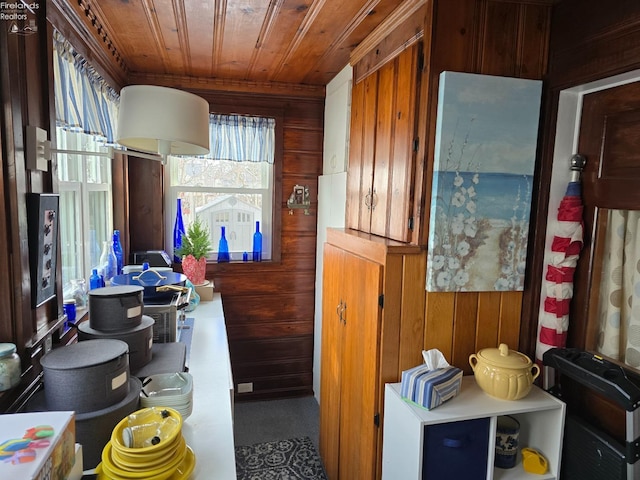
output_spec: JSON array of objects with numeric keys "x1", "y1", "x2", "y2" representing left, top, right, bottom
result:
[{"x1": 166, "y1": 115, "x2": 275, "y2": 261}]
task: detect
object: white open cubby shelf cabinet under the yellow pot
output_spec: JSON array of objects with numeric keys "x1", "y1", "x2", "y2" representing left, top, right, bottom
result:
[{"x1": 382, "y1": 376, "x2": 565, "y2": 480}]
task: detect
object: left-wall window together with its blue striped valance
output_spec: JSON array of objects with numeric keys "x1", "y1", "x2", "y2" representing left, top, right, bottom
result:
[{"x1": 53, "y1": 30, "x2": 118, "y2": 294}]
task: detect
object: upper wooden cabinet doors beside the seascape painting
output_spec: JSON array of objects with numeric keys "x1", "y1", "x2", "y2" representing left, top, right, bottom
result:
[{"x1": 347, "y1": 43, "x2": 422, "y2": 241}]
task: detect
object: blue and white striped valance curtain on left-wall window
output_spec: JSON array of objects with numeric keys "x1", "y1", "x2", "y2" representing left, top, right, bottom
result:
[{"x1": 53, "y1": 30, "x2": 119, "y2": 144}]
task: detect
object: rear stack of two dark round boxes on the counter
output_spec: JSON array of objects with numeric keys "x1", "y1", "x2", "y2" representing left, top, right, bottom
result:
[{"x1": 78, "y1": 285, "x2": 155, "y2": 372}]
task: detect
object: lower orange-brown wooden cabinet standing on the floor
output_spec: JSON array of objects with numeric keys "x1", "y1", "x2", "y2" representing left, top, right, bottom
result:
[{"x1": 320, "y1": 229, "x2": 425, "y2": 480}]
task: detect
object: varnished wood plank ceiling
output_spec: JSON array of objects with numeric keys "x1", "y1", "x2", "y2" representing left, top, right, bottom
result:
[{"x1": 61, "y1": 0, "x2": 415, "y2": 90}]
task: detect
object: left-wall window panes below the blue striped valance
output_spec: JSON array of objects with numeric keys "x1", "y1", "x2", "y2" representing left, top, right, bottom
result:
[{"x1": 56, "y1": 127, "x2": 113, "y2": 291}]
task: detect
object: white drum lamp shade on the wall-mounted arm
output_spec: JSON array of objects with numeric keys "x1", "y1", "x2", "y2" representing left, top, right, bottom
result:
[{"x1": 116, "y1": 85, "x2": 209, "y2": 155}]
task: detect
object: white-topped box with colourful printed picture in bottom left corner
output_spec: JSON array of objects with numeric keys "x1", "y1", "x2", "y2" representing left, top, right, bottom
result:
[{"x1": 0, "y1": 411, "x2": 76, "y2": 480}]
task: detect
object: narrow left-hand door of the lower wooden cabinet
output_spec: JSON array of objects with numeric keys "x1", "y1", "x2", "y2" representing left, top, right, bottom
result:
[{"x1": 320, "y1": 243, "x2": 344, "y2": 479}]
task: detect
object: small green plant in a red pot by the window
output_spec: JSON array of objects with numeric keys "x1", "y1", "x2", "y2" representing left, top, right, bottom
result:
[{"x1": 176, "y1": 217, "x2": 213, "y2": 285}]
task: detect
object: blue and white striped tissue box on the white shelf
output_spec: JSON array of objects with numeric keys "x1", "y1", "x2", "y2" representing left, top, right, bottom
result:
[{"x1": 400, "y1": 364, "x2": 462, "y2": 410}]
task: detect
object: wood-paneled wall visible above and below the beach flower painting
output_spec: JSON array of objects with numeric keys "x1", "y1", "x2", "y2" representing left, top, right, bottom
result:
[{"x1": 418, "y1": 0, "x2": 551, "y2": 373}]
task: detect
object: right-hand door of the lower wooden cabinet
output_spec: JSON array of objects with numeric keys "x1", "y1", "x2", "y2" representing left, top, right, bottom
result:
[{"x1": 337, "y1": 249, "x2": 383, "y2": 480}]
